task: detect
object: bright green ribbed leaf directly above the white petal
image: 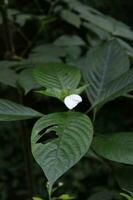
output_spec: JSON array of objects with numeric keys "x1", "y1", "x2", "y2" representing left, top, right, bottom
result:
[{"x1": 33, "y1": 63, "x2": 81, "y2": 90}]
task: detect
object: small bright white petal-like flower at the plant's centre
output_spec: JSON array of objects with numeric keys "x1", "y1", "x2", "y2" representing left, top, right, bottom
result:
[{"x1": 64, "y1": 94, "x2": 82, "y2": 110}]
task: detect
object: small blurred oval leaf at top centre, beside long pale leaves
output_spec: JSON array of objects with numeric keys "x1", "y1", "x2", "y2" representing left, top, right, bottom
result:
[{"x1": 61, "y1": 10, "x2": 81, "y2": 28}]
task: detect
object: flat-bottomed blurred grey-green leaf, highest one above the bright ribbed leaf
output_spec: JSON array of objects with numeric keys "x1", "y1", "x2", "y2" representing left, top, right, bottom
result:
[{"x1": 54, "y1": 35, "x2": 85, "y2": 46}]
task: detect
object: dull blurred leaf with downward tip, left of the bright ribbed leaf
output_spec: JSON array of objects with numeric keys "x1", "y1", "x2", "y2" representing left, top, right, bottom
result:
[{"x1": 18, "y1": 69, "x2": 40, "y2": 94}]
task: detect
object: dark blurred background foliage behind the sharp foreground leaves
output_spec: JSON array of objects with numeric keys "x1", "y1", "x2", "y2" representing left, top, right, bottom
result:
[{"x1": 0, "y1": 0, "x2": 133, "y2": 200}]
